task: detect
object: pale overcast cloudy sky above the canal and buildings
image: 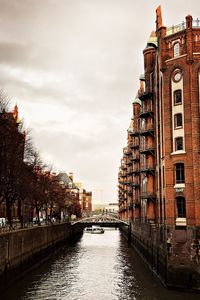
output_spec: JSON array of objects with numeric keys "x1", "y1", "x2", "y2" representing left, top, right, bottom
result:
[{"x1": 0, "y1": 0, "x2": 200, "y2": 202}]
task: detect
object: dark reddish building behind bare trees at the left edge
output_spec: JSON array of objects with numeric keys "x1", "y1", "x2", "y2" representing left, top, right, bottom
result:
[{"x1": 0, "y1": 106, "x2": 25, "y2": 219}]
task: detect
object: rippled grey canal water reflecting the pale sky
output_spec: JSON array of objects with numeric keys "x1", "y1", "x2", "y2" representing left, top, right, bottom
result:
[{"x1": 0, "y1": 229, "x2": 199, "y2": 300}]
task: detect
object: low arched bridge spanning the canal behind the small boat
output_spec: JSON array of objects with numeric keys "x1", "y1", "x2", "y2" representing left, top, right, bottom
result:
[{"x1": 72, "y1": 214, "x2": 128, "y2": 227}]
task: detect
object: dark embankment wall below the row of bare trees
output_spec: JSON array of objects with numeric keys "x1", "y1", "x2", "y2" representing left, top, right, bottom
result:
[{"x1": 0, "y1": 223, "x2": 82, "y2": 290}]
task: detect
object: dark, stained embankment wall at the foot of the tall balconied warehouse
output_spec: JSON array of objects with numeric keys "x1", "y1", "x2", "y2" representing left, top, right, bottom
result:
[{"x1": 122, "y1": 225, "x2": 200, "y2": 292}]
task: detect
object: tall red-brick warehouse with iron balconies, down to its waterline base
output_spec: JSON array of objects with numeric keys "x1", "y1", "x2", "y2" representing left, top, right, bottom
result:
[{"x1": 118, "y1": 7, "x2": 200, "y2": 289}]
